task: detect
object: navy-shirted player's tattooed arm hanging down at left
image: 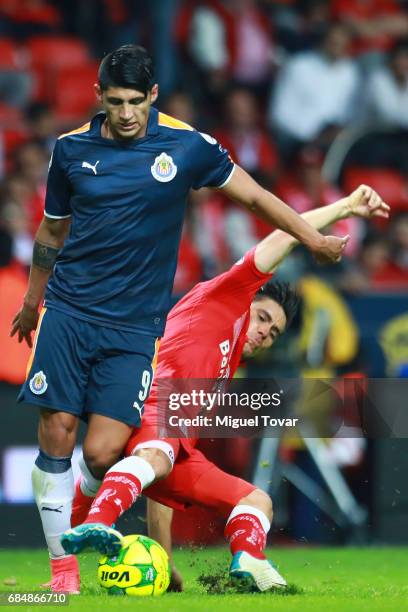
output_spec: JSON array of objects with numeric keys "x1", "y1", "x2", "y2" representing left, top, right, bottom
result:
[{"x1": 10, "y1": 217, "x2": 70, "y2": 347}]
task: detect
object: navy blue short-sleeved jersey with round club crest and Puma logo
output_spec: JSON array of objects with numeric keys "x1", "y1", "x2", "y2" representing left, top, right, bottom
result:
[{"x1": 45, "y1": 108, "x2": 234, "y2": 336}]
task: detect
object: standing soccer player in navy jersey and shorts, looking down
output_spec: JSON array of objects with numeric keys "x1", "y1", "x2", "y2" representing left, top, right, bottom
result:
[{"x1": 11, "y1": 45, "x2": 345, "y2": 593}]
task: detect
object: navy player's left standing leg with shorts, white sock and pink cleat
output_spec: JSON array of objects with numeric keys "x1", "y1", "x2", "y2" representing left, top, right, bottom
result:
[{"x1": 19, "y1": 309, "x2": 89, "y2": 592}]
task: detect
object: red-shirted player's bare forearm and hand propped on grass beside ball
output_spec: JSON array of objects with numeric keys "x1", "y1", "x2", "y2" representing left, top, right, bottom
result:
[{"x1": 147, "y1": 499, "x2": 183, "y2": 592}]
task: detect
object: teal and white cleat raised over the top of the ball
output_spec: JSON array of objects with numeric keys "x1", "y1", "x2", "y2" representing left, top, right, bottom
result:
[{"x1": 61, "y1": 523, "x2": 123, "y2": 557}]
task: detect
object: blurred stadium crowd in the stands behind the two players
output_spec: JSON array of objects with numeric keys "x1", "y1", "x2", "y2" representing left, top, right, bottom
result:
[{"x1": 0, "y1": 0, "x2": 408, "y2": 544}]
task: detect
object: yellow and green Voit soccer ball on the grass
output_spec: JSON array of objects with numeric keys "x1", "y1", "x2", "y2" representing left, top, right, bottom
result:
[{"x1": 98, "y1": 535, "x2": 170, "y2": 597}]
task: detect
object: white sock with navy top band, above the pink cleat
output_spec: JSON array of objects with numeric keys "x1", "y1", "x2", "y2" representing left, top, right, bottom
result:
[{"x1": 31, "y1": 450, "x2": 74, "y2": 559}]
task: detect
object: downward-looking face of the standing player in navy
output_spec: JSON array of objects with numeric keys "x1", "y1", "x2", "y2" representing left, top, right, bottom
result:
[{"x1": 95, "y1": 85, "x2": 158, "y2": 140}]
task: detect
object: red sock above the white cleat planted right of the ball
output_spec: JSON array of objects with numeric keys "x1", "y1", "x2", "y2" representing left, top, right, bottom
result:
[{"x1": 224, "y1": 513, "x2": 266, "y2": 559}]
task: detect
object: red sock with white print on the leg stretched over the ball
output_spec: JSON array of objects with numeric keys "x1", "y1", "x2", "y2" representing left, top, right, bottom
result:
[{"x1": 84, "y1": 472, "x2": 142, "y2": 527}]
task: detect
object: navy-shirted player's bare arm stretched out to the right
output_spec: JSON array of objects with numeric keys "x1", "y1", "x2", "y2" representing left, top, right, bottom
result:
[{"x1": 222, "y1": 166, "x2": 350, "y2": 263}]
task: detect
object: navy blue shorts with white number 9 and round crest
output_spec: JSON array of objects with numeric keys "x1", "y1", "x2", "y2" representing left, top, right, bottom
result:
[{"x1": 18, "y1": 308, "x2": 159, "y2": 426}]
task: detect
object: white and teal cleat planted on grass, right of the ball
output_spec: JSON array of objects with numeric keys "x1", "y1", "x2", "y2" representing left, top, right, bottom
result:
[{"x1": 230, "y1": 551, "x2": 286, "y2": 591}]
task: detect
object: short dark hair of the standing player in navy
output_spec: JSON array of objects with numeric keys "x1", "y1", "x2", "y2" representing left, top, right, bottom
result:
[{"x1": 98, "y1": 45, "x2": 155, "y2": 94}]
